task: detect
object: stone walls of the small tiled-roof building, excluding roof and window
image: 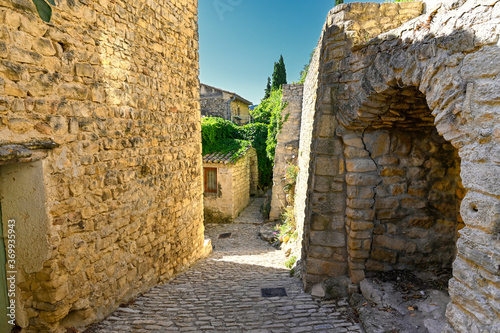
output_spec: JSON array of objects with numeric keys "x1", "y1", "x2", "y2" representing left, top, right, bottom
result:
[{"x1": 203, "y1": 148, "x2": 258, "y2": 223}]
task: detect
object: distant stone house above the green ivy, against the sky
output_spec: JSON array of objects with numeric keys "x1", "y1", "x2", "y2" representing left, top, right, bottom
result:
[{"x1": 200, "y1": 83, "x2": 252, "y2": 125}]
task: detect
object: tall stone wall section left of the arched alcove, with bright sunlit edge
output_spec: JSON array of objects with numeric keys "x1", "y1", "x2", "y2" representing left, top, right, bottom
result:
[{"x1": 296, "y1": 2, "x2": 422, "y2": 289}]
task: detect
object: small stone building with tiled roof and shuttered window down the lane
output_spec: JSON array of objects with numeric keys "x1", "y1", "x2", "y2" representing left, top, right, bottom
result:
[{"x1": 203, "y1": 147, "x2": 259, "y2": 223}]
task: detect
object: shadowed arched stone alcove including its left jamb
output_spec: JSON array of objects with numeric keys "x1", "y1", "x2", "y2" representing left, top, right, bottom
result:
[{"x1": 339, "y1": 87, "x2": 465, "y2": 283}]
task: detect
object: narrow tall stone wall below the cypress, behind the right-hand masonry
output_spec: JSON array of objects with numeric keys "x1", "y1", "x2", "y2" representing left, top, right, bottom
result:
[{"x1": 269, "y1": 84, "x2": 304, "y2": 221}]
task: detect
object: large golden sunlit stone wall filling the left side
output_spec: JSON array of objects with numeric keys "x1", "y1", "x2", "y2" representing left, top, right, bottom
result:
[{"x1": 0, "y1": 0, "x2": 204, "y2": 332}]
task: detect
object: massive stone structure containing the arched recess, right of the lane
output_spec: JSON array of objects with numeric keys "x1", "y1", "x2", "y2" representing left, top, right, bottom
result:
[{"x1": 295, "y1": 0, "x2": 500, "y2": 333}]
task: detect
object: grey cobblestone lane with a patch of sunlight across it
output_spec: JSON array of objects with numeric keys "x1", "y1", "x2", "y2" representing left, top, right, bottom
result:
[{"x1": 94, "y1": 200, "x2": 362, "y2": 333}]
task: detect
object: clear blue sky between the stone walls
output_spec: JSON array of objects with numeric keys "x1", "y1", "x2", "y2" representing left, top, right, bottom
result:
[{"x1": 198, "y1": 0, "x2": 383, "y2": 104}]
